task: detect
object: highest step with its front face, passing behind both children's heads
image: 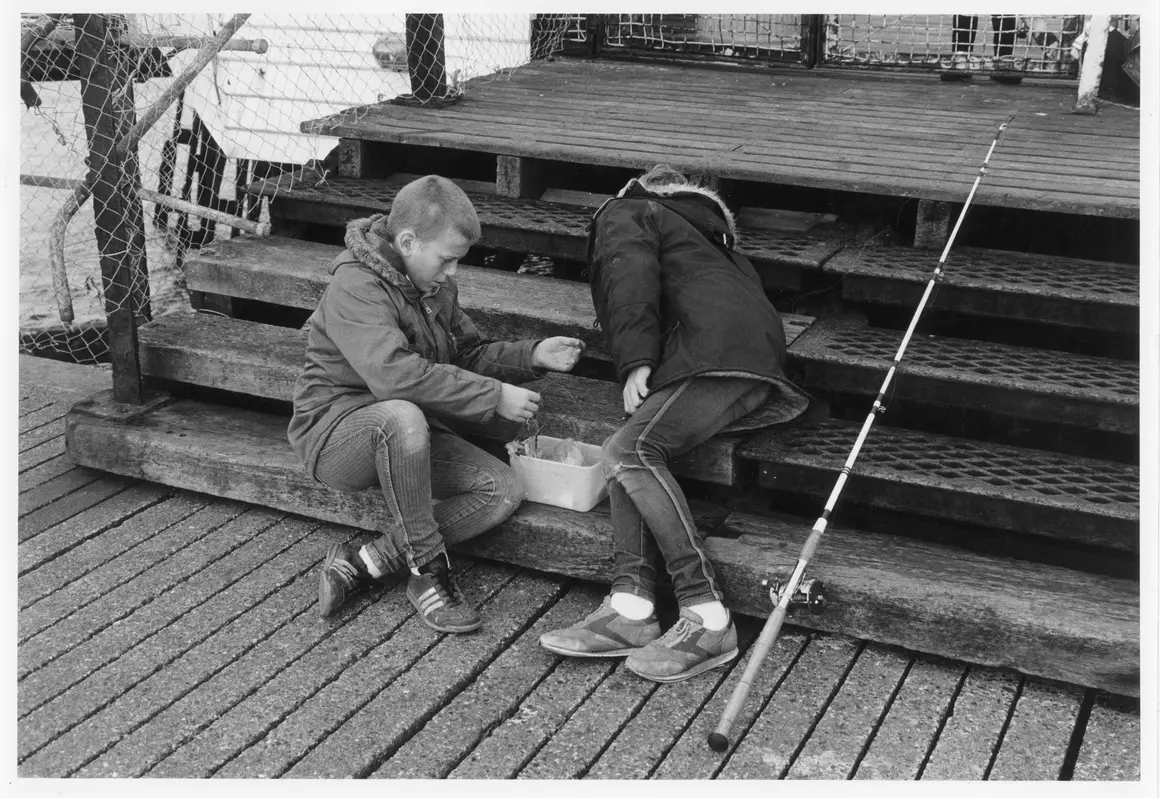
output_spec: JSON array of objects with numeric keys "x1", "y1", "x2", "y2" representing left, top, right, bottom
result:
[{"x1": 249, "y1": 173, "x2": 846, "y2": 289}]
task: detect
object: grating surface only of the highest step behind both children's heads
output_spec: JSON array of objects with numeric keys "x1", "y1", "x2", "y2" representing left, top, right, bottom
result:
[{"x1": 247, "y1": 173, "x2": 843, "y2": 269}]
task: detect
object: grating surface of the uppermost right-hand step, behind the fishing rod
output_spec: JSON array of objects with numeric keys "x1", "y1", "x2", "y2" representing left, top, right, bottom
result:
[{"x1": 825, "y1": 247, "x2": 1140, "y2": 307}]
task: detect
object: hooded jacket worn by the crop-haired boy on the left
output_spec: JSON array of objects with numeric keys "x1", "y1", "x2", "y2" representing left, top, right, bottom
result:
[{"x1": 288, "y1": 216, "x2": 544, "y2": 476}]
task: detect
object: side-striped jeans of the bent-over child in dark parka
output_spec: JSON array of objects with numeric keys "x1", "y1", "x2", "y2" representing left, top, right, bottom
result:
[{"x1": 603, "y1": 377, "x2": 770, "y2": 607}]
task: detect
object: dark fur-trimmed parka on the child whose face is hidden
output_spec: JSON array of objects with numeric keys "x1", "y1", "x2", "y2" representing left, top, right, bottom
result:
[{"x1": 588, "y1": 180, "x2": 810, "y2": 429}]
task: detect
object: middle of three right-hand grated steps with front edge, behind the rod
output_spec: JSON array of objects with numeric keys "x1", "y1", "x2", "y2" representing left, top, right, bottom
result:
[{"x1": 789, "y1": 319, "x2": 1140, "y2": 435}]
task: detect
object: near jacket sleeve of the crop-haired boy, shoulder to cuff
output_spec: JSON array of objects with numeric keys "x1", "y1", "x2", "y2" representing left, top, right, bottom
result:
[{"x1": 324, "y1": 271, "x2": 500, "y2": 423}]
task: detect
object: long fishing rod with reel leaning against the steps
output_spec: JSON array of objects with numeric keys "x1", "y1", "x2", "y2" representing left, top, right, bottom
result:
[{"x1": 709, "y1": 114, "x2": 1015, "y2": 752}]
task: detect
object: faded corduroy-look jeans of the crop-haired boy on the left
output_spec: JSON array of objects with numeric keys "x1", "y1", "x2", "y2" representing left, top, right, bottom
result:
[{"x1": 314, "y1": 400, "x2": 523, "y2": 575}]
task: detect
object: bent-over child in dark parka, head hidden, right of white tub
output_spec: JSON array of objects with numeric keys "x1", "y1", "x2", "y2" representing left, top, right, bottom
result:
[{"x1": 541, "y1": 165, "x2": 810, "y2": 682}]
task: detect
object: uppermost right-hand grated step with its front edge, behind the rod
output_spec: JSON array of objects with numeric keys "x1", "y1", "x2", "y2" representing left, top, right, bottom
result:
[{"x1": 822, "y1": 247, "x2": 1140, "y2": 333}]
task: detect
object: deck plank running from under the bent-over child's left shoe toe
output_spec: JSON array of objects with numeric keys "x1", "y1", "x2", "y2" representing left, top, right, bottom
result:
[{"x1": 370, "y1": 585, "x2": 602, "y2": 778}]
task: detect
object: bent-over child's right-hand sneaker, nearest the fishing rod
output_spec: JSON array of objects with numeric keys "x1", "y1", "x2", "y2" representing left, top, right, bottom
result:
[{"x1": 624, "y1": 608, "x2": 738, "y2": 682}]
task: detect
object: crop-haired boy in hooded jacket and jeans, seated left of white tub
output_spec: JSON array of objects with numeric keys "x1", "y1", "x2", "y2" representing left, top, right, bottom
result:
[{"x1": 288, "y1": 175, "x2": 582, "y2": 632}]
